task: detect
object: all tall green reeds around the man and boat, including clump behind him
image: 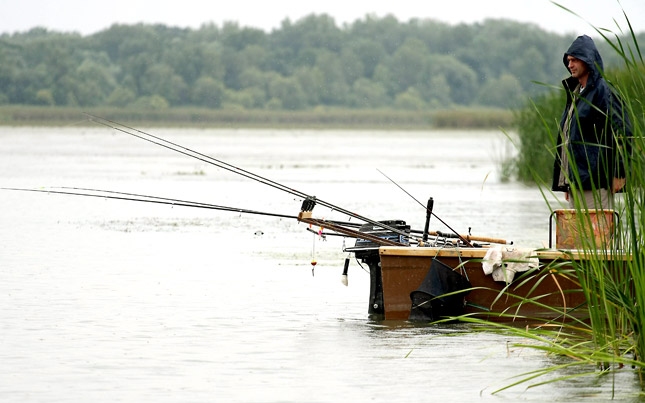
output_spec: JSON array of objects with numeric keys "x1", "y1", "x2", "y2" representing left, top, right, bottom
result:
[{"x1": 468, "y1": 7, "x2": 645, "y2": 390}]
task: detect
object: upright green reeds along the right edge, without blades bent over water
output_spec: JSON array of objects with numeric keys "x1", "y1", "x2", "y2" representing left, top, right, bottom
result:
[{"x1": 560, "y1": 17, "x2": 645, "y2": 372}]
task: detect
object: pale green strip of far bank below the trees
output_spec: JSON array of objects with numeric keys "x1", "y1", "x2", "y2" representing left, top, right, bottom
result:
[{"x1": 0, "y1": 105, "x2": 514, "y2": 130}]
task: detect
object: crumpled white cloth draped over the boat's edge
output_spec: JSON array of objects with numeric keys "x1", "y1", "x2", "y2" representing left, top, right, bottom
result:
[{"x1": 482, "y1": 245, "x2": 540, "y2": 283}]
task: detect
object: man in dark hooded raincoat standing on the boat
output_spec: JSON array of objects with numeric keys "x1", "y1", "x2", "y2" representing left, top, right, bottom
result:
[{"x1": 552, "y1": 35, "x2": 631, "y2": 209}]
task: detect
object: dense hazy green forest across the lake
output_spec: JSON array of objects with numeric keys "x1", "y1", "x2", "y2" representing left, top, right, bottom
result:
[{"x1": 0, "y1": 14, "x2": 640, "y2": 110}]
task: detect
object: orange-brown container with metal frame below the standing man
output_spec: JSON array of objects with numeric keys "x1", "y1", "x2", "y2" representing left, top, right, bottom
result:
[{"x1": 549, "y1": 209, "x2": 618, "y2": 249}]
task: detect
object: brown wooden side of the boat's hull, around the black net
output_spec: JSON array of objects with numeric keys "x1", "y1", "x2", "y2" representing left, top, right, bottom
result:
[{"x1": 379, "y1": 246, "x2": 586, "y2": 321}]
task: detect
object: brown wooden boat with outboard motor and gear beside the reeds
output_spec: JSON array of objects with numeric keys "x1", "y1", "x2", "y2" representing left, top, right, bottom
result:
[{"x1": 298, "y1": 203, "x2": 624, "y2": 322}]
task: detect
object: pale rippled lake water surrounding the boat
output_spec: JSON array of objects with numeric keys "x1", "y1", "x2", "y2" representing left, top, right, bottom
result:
[{"x1": 0, "y1": 126, "x2": 639, "y2": 403}]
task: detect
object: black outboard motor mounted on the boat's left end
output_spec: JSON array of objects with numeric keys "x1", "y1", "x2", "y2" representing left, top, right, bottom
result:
[{"x1": 349, "y1": 220, "x2": 410, "y2": 320}]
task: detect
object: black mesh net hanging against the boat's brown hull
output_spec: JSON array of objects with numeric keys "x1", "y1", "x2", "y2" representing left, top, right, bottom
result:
[{"x1": 408, "y1": 259, "x2": 472, "y2": 322}]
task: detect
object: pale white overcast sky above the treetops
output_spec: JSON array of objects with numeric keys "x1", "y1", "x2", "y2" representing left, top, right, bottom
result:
[{"x1": 0, "y1": 0, "x2": 645, "y2": 36}]
